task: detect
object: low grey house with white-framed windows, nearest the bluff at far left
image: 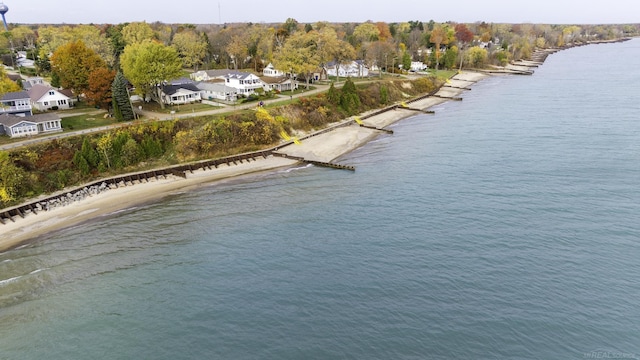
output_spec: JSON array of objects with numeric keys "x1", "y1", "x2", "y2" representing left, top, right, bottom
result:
[{"x1": 0, "y1": 113, "x2": 62, "y2": 138}]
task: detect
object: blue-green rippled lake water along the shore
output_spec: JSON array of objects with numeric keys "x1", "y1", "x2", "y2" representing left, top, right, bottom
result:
[{"x1": 0, "y1": 39, "x2": 640, "y2": 359}]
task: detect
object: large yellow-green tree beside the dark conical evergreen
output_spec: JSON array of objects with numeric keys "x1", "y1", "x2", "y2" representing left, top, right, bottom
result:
[{"x1": 120, "y1": 40, "x2": 182, "y2": 109}]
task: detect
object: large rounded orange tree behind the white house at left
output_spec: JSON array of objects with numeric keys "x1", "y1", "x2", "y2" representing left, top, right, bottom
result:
[{"x1": 51, "y1": 40, "x2": 106, "y2": 94}]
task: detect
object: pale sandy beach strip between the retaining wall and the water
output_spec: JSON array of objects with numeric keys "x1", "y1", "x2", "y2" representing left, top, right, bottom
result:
[{"x1": 0, "y1": 72, "x2": 487, "y2": 251}]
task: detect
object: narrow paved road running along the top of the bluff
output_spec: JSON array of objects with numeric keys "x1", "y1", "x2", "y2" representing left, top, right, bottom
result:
[{"x1": 0, "y1": 84, "x2": 330, "y2": 150}]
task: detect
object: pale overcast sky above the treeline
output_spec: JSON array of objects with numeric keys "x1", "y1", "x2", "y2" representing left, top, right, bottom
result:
[{"x1": 6, "y1": 0, "x2": 640, "y2": 24}]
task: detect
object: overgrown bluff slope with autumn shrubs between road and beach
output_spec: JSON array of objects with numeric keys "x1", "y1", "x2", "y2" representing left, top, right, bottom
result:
[{"x1": 0, "y1": 76, "x2": 442, "y2": 208}]
